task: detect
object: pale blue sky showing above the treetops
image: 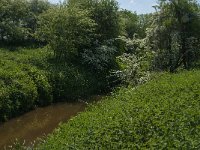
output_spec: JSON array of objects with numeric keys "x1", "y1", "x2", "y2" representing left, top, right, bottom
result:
[{"x1": 49, "y1": 0, "x2": 156, "y2": 14}]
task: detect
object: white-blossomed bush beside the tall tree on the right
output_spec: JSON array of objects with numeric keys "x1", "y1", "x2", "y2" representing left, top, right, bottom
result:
[{"x1": 115, "y1": 37, "x2": 154, "y2": 86}]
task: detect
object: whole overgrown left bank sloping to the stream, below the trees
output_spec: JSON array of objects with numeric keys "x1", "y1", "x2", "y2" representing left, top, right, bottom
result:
[{"x1": 0, "y1": 48, "x2": 107, "y2": 122}]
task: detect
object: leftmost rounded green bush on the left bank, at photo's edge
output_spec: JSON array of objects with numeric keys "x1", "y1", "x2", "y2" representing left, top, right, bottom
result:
[{"x1": 0, "y1": 61, "x2": 38, "y2": 121}]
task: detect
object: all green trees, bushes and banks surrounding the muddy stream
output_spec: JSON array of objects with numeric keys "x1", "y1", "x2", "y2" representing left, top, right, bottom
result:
[{"x1": 0, "y1": 0, "x2": 200, "y2": 149}]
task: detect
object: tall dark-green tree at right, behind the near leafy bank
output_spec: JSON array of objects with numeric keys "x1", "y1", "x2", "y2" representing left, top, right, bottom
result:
[{"x1": 148, "y1": 0, "x2": 200, "y2": 72}]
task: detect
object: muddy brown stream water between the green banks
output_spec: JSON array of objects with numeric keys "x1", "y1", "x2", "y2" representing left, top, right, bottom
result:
[{"x1": 0, "y1": 103, "x2": 86, "y2": 149}]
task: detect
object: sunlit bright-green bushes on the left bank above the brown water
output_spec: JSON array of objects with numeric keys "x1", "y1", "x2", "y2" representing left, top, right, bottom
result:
[{"x1": 0, "y1": 50, "x2": 53, "y2": 121}]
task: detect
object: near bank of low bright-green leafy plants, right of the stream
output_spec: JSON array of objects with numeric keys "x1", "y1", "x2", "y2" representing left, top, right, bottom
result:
[{"x1": 38, "y1": 71, "x2": 200, "y2": 150}]
